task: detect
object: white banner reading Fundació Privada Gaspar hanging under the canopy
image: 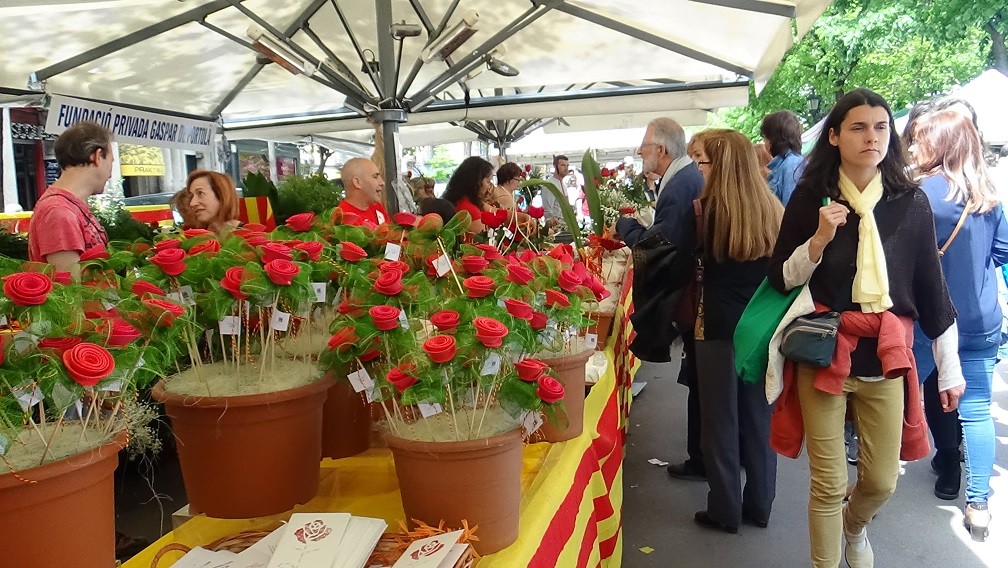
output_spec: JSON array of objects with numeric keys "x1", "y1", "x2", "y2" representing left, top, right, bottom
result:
[{"x1": 45, "y1": 95, "x2": 217, "y2": 151}]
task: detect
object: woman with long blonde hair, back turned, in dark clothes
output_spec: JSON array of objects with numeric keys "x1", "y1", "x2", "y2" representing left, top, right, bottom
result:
[{"x1": 689, "y1": 129, "x2": 783, "y2": 534}]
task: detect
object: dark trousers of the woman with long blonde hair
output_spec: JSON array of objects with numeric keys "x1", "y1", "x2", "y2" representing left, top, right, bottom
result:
[{"x1": 697, "y1": 340, "x2": 777, "y2": 527}]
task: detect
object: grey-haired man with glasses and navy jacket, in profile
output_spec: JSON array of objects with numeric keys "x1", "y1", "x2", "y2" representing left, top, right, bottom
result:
[{"x1": 616, "y1": 118, "x2": 707, "y2": 481}]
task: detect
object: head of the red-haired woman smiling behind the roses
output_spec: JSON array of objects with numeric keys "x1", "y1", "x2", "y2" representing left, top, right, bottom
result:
[{"x1": 171, "y1": 169, "x2": 239, "y2": 234}]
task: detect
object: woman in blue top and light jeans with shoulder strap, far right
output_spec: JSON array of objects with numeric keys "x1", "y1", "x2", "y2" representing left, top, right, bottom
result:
[{"x1": 908, "y1": 108, "x2": 1008, "y2": 541}]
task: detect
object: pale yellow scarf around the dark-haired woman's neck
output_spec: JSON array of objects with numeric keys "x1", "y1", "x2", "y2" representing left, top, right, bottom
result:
[{"x1": 840, "y1": 169, "x2": 892, "y2": 314}]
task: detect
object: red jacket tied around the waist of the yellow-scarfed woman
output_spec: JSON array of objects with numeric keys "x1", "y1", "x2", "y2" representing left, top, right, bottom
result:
[{"x1": 770, "y1": 311, "x2": 930, "y2": 461}]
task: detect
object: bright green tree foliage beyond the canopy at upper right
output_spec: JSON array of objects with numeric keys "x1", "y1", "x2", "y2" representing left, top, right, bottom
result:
[{"x1": 721, "y1": 0, "x2": 991, "y2": 138}]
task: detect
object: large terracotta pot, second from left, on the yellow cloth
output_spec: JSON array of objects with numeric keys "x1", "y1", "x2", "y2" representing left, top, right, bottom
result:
[{"x1": 151, "y1": 380, "x2": 331, "y2": 519}]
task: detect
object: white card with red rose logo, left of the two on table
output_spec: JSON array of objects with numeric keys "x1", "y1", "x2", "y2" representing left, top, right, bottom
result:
[{"x1": 269, "y1": 513, "x2": 350, "y2": 568}]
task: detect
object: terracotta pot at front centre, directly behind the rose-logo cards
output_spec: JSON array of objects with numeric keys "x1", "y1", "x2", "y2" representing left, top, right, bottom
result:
[{"x1": 385, "y1": 429, "x2": 522, "y2": 554}]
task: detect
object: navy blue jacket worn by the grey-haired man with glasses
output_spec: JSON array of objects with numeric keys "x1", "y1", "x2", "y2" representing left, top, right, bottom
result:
[{"x1": 616, "y1": 162, "x2": 704, "y2": 251}]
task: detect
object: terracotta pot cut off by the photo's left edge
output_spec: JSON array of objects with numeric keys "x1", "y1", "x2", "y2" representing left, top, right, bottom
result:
[{"x1": 0, "y1": 434, "x2": 126, "y2": 568}]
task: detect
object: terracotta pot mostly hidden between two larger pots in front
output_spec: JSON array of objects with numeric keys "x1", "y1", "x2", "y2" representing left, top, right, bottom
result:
[{"x1": 322, "y1": 373, "x2": 371, "y2": 459}]
